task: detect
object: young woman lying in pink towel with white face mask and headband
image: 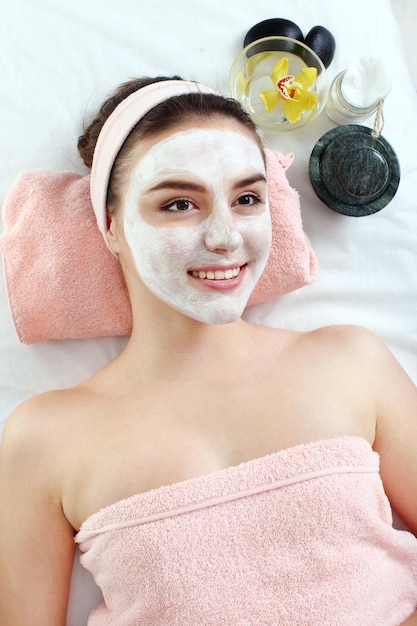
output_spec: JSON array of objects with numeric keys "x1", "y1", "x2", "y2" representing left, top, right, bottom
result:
[{"x1": 0, "y1": 79, "x2": 417, "y2": 626}]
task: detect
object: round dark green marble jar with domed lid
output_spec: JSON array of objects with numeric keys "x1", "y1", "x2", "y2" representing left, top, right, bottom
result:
[{"x1": 309, "y1": 124, "x2": 400, "y2": 217}]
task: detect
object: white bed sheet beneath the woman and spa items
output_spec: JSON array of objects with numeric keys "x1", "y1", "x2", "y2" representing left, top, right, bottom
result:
[{"x1": 0, "y1": 0, "x2": 417, "y2": 626}]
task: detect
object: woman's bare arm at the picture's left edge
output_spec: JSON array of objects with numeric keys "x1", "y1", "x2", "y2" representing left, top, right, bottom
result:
[{"x1": 0, "y1": 401, "x2": 74, "y2": 626}]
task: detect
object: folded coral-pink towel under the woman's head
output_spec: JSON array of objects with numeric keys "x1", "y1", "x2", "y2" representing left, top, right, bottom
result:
[{"x1": 0, "y1": 151, "x2": 317, "y2": 343}]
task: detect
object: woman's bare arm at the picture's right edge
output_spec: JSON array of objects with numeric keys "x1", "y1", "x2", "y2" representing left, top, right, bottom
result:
[{"x1": 333, "y1": 327, "x2": 417, "y2": 626}]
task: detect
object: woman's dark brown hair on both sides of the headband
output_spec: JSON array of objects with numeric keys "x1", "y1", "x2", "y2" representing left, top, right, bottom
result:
[{"x1": 78, "y1": 76, "x2": 262, "y2": 212}]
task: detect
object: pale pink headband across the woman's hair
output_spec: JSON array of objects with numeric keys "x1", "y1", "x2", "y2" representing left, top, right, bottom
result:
[{"x1": 90, "y1": 80, "x2": 217, "y2": 248}]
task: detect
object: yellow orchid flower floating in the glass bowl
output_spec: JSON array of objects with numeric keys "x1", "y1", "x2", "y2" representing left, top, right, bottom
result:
[{"x1": 259, "y1": 57, "x2": 317, "y2": 124}]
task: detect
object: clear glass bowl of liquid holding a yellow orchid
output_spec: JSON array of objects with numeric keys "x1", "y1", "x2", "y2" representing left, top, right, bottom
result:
[{"x1": 229, "y1": 36, "x2": 328, "y2": 132}]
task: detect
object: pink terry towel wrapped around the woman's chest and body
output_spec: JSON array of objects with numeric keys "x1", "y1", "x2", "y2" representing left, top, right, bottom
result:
[{"x1": 76, "y1": 437, "x2": 417, "y2": 626}]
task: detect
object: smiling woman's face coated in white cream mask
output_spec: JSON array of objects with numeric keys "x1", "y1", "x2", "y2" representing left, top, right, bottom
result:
[{"x1": 119, "y1": 128, "x2": 271, "y2": 324}]
